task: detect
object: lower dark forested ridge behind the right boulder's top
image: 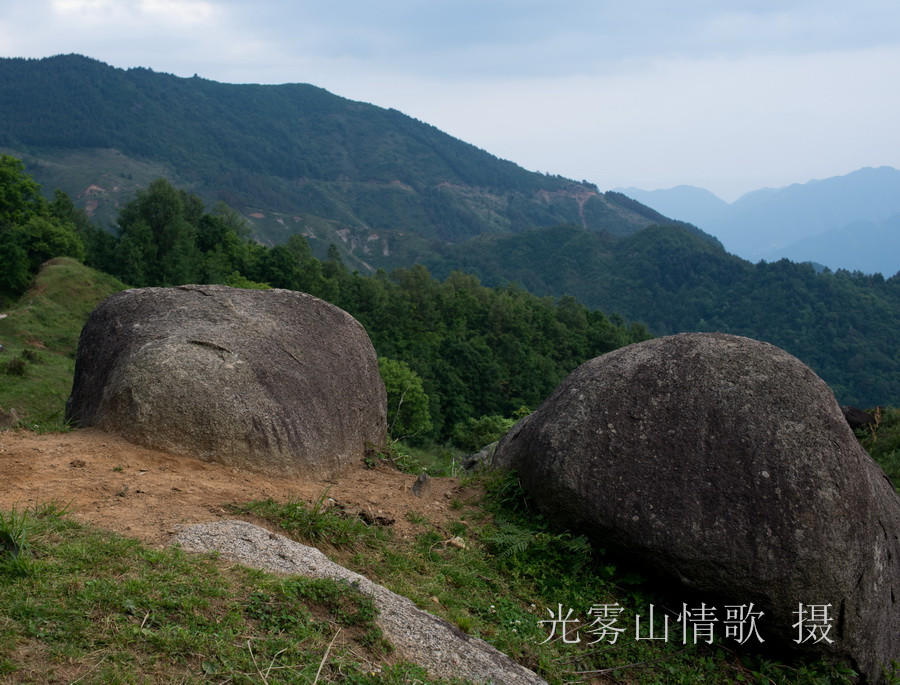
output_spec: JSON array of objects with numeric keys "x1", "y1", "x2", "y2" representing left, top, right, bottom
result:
[{"x1": 425, "y1": 226, "x2": 900, "y2": 406}]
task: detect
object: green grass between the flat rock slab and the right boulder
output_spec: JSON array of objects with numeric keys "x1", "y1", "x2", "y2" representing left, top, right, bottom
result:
[{"x1": 230, "y1": 457, "x2": 852, "y2": 683}]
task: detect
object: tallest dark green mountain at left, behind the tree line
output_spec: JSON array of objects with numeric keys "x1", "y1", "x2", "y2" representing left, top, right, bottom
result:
[{"x1": 0, "y1": 55, "x2": 712, "y2": 268}]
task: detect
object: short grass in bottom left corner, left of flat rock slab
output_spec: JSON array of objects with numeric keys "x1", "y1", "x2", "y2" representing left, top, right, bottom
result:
[{"x1": 0, "y1": 504, "x2": 442, "y2": 685}]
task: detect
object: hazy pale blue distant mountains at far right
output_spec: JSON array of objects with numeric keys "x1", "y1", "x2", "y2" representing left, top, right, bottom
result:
[{"x1": 619, "y1": 166, "x2": 900, "y2": 276}]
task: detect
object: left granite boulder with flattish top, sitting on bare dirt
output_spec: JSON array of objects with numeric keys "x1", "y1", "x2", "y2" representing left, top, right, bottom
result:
[{"x1": 66, "y1": 285, "x2": 387, "y2": 477}]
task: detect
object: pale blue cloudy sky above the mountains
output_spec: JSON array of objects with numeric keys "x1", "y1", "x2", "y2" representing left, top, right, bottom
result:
[{"x1": 0, "y1": 0, "x2": 900, "y2": 201}]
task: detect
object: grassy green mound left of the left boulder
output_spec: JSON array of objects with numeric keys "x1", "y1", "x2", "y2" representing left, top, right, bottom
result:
[{"x1": 0, "y1": 258, "x2": 126, "y2": 431}]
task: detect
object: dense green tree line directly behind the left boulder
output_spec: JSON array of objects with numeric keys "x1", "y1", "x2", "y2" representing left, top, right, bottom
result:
[{"x1": 0, "y1": 163, "x2": 650, "y2": 441}]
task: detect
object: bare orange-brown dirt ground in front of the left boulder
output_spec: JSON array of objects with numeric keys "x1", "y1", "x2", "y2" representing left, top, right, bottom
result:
[{"x1": 0, "y1": 429, "x2": 472, "y2": 545}]
